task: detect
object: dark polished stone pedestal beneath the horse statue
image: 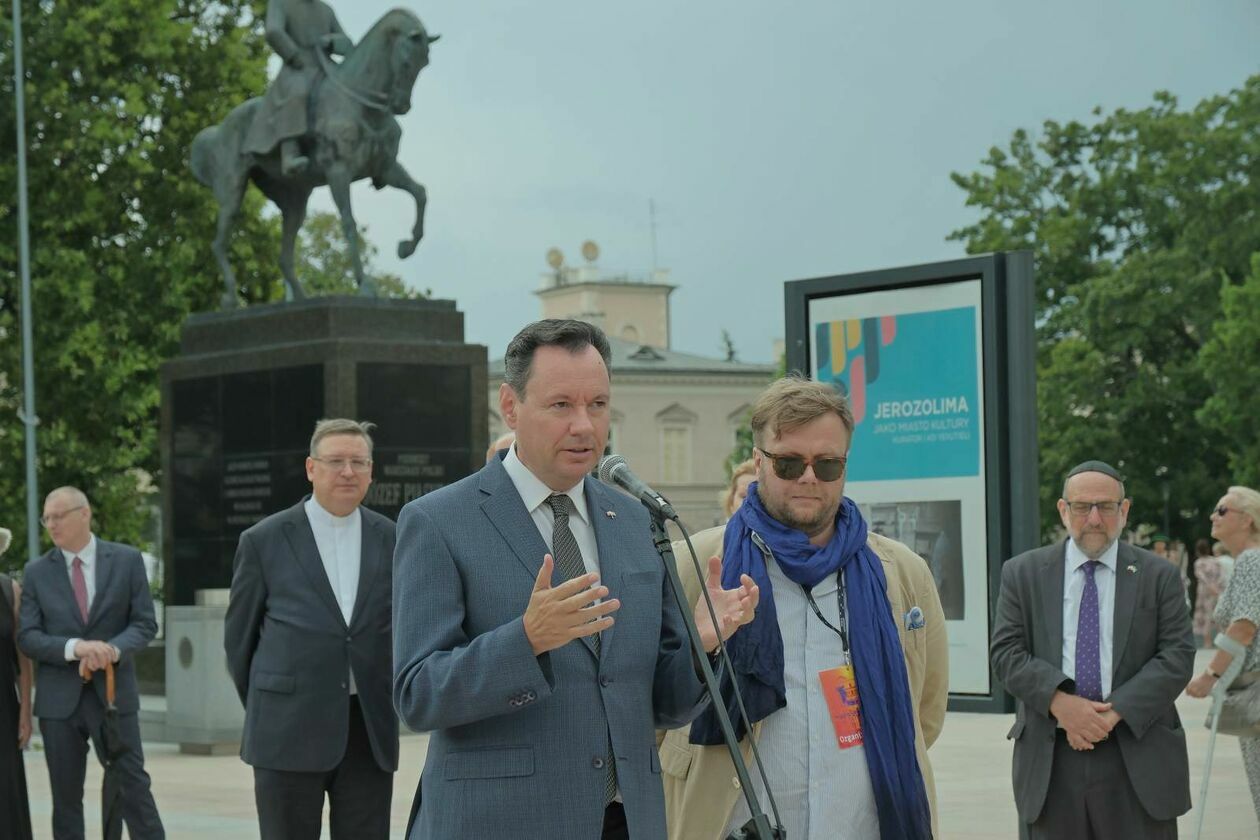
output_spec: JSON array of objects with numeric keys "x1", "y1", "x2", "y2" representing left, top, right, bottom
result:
[{"x1": 161, "y1": 297, "x2": 486, "y2": 607}]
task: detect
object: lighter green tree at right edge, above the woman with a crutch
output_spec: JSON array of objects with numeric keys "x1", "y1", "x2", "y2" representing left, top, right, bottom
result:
[{"x1": 1198, "y1": 253, "x2": 1260, "y2": 495}]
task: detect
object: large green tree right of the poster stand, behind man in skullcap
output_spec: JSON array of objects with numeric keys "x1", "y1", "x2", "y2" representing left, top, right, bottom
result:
[{"x1": 950, "y1": 76, "x2": 1260, "y2": 539}]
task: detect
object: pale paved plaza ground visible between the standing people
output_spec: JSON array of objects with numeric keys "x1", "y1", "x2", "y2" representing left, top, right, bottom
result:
[{"x1": 19, "y1": 651, "x2": 1257, "y2": 840}]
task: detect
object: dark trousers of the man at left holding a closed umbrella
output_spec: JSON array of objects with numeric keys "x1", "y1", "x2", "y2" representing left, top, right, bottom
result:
[{"x1": 39, "y1": 685, "x2": 166, "y2": 840}]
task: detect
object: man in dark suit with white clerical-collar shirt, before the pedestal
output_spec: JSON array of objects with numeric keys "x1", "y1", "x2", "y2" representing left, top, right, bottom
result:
[{"x1": 223, "y1": 419, "x2": 398, "y2": 840}]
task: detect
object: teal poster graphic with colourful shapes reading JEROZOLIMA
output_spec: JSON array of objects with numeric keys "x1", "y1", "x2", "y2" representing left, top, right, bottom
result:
[{"x1": 814, "y1": 306, "x2": 980, "y2": 481}]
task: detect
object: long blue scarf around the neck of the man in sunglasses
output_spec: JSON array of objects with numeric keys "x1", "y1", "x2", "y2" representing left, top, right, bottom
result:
[{"x1": 690, "y1": 484, "x2": 932, "y2": 840}]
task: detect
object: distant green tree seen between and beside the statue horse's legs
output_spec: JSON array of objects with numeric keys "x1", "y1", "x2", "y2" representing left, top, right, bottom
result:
[{"x1": 296, "y1": 213, "x2": 432, "y2": 300}]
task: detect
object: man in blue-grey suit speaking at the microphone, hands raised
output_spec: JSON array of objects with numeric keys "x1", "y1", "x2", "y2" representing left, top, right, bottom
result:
[{"x1": 394, "y1": 320, "x2": 757, "y2": 840}]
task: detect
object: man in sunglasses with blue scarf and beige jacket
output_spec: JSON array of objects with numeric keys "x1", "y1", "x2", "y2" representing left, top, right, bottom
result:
[{"x1": 660, "y1": 377, "x2": 949, "y2": 840}]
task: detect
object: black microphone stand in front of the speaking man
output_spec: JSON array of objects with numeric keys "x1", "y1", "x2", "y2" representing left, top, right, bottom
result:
[{"x1": 644, "y1": 502, "x2": 786, "y2": 840}]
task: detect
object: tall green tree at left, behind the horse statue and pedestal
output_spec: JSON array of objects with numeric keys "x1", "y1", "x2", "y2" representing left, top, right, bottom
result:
[{"x1": 0, "y1": 0, "x2": 281, "y2": 565}]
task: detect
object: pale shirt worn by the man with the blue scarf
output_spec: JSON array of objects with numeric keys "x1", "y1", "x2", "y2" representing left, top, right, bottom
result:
[{"x1": 723, "y1": 560, "x2": 879, "y2": 840}]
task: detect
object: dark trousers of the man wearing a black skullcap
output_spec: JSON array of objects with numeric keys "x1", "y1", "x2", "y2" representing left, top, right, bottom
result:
[{"x1": 1028, "y1": 729, "x2": 1177, "y2": 840}]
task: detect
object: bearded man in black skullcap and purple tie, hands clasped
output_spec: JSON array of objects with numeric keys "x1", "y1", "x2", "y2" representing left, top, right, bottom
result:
[{"x1": 989, "y1": 461, "x2": 1194, "y2": 840}]
